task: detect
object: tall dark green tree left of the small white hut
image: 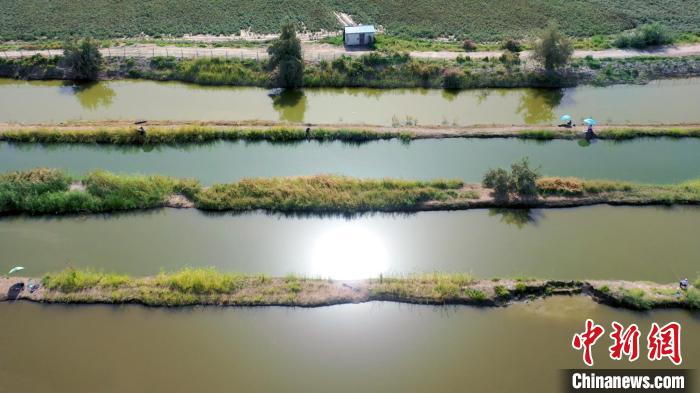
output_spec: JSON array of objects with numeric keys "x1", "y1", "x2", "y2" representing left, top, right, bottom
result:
[{"x1": 267, "y1": 22, "x2": 304, "y2": 87}]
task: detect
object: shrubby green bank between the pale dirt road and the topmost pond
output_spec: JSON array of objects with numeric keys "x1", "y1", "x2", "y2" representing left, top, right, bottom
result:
[{"x1": 5, "y1": 53, "x2": 700, "y2": 89}]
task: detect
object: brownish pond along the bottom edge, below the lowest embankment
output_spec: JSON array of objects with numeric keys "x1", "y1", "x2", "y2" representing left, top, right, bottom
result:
[{"x1": 0, "y1": 297, "x2": 700, "y2": 393}]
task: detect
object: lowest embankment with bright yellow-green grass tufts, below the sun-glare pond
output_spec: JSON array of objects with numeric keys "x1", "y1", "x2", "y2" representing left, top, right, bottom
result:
[{"x1": 0, "y1": 268, "x2": 700, "y2": 310}]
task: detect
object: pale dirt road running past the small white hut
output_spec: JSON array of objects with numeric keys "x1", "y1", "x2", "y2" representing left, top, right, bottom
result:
[{"x1": 5, "y1": 42, "x2": 700, "y2": 61}]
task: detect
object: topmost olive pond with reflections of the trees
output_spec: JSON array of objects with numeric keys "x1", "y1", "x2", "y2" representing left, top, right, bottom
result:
[{"x1": 0, "y1": 78, "x2": 700, "y2": 125}]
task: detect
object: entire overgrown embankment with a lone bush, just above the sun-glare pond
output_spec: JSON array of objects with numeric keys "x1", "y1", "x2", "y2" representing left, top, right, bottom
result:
[{"x1": 0, "y1": 168, "x2": 700, "y2": 214}]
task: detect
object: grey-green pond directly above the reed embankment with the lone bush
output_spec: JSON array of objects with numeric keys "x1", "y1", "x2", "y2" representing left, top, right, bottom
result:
[{"x1": 0, "y1": 139, "x2": 700, "y2": 184}]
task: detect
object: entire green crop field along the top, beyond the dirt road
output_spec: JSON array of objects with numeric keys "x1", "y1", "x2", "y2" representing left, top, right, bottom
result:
[{"x1": 0, "y1": 0, "x2": 700, "y2": 41}]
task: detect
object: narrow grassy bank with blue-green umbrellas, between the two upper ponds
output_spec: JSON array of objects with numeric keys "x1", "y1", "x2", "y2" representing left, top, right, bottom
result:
[{"x1": 0, "y1": 121, "x2": 700, "y2": 145}]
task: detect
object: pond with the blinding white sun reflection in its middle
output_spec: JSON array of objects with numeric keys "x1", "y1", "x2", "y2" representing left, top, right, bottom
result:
[{"x1": 0, "y1": 206, "x2": 700, "y2": 282}]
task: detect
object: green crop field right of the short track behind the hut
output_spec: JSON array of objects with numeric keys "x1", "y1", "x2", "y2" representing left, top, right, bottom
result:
[{"x1": 334, "y1": 0, "x2": 700, "y2": 41}]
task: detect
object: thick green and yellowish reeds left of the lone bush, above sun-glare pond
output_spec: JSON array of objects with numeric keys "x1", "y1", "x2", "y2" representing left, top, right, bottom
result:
[{"x1": 0, "y1": 169, "x2": 470, "y2": 214}]
